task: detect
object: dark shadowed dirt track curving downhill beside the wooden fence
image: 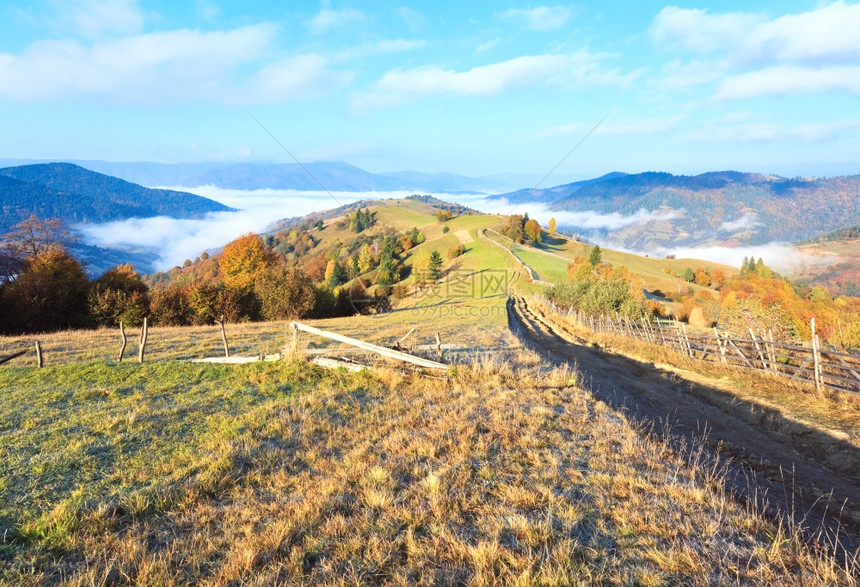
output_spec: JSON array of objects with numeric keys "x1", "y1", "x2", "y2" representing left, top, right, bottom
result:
[{"x1": 508, "y1": 296, "x2": 860, "y2": 553}]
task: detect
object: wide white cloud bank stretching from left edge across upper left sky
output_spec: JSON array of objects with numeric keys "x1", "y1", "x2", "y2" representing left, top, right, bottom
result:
[{"x1": 0, "y1": 24, "x2": 352, "y2": 105}]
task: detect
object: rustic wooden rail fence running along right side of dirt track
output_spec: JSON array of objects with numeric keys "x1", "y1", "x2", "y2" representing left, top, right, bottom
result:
[{"x1": 536, "y1": 296, "x2": 860, "y2": 395}]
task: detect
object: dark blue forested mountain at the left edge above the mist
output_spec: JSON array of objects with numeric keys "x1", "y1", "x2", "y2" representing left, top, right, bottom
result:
[{"x1": 0, "y1": 163, "x2": 233, "y2": 233}]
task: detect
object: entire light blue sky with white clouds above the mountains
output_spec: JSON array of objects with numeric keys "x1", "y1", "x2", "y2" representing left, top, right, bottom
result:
[{"x1": 0, "y1": 0, "x2": 860, "y2": 179}]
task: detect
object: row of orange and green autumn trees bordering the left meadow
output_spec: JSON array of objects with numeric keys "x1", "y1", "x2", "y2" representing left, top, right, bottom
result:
[{"x1": 0, "y1": 215, "x2": 423, "y2": 334}]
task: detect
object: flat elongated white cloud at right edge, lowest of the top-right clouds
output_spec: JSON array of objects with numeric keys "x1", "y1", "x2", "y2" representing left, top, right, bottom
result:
[{"x1": 714, "y1": 65, "x2": 860, "y2": 100}]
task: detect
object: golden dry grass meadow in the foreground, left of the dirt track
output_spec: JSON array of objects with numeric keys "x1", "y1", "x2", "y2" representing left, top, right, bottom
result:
[{"x1": 0, "y1": 352, "x2": 856, "y2": 585}]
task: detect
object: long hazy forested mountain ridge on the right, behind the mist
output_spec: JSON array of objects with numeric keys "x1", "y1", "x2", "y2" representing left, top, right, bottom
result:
[{"x1": 494, "y1": 171, "x2": 860, "y2": 251}]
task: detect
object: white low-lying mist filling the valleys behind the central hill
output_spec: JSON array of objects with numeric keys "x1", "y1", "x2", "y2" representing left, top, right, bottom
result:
[{"x1": 77, "y1": 186, "x2": 829, "y2": 274}]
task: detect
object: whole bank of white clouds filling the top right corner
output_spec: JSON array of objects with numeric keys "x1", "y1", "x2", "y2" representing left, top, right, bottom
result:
[{"x1": 650, "y1": 0, "x2": 860, "y2": 99}]
